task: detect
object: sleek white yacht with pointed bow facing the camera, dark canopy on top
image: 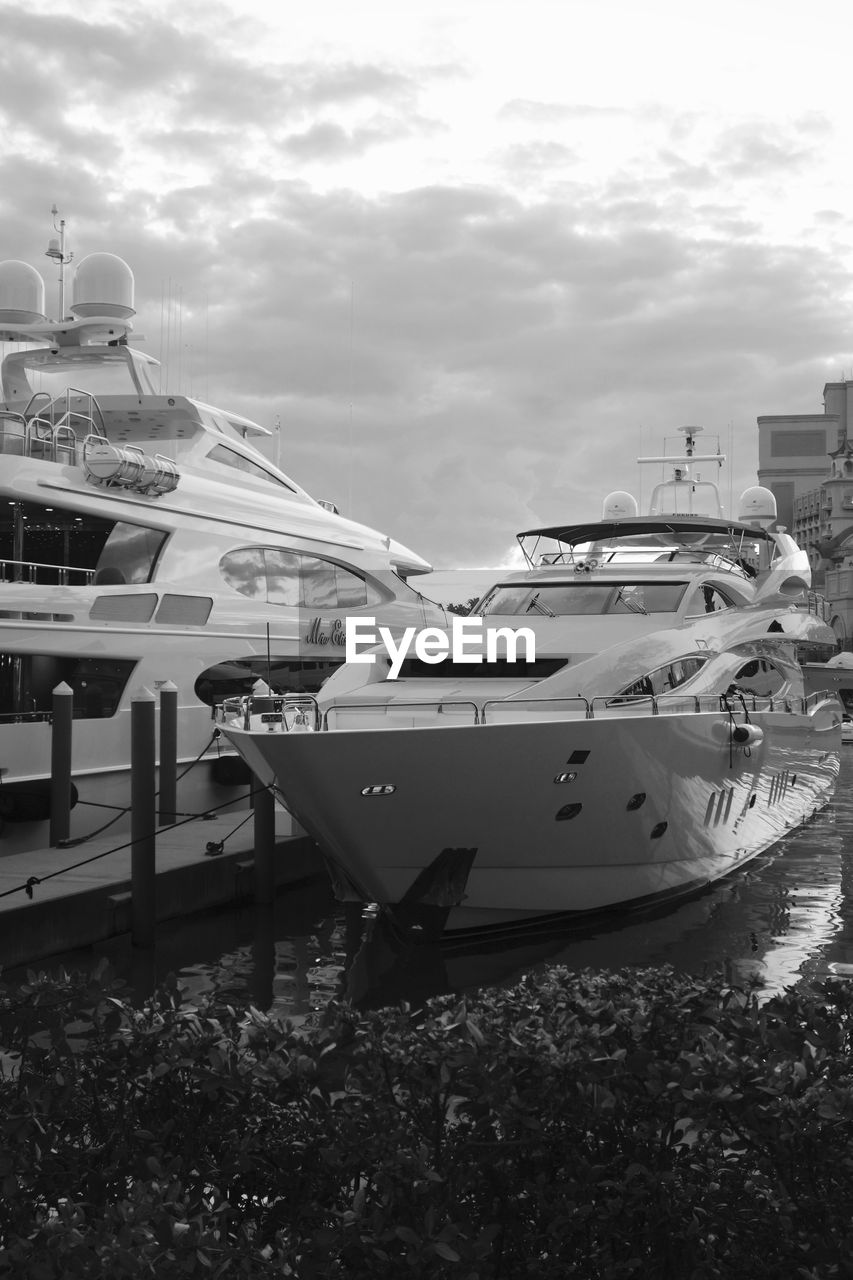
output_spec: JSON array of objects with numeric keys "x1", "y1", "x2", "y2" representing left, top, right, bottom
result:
[{"x1": 224, "y1": 429, "x2": 841, "y2": 928}]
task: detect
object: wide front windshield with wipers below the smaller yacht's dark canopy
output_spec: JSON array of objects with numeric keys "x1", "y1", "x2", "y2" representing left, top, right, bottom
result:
[{"x1": 473, "y1": 581, "x2": 688, "y2": 618}]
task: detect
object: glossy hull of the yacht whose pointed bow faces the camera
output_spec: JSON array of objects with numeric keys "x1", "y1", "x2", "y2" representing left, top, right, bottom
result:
[{"x1": 225, "y1": 699, "x2": 840, "y2": 927}]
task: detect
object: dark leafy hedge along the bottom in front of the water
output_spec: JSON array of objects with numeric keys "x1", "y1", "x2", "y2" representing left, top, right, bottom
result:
[{"x1": 0, "y1": 968, "x2": 853, "y2": 1280}]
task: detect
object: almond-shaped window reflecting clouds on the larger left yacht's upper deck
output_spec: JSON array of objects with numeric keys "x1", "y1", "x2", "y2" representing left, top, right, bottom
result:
[{"x1": 219, "y1": 547, "x2": 383, "y2": 611}]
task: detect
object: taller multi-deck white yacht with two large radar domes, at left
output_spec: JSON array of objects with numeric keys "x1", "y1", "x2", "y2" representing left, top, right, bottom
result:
[{"x1": 0, "y1": 244, "x2": 444, "y2": 855}]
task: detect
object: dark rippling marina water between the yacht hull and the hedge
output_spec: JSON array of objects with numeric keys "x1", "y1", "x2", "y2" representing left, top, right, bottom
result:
[{"x1": 16, "y1": 746, "x2": 853, "y2": 1021}]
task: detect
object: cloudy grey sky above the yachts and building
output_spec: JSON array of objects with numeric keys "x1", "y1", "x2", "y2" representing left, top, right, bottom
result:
[{"x1": 0, "y1": 0, "x2": 853, "y2": 567}]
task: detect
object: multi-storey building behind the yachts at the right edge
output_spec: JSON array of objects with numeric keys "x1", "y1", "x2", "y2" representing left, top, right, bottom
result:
[{"x1": 758, "y1": 381, "x2": 853, "y2": 649}]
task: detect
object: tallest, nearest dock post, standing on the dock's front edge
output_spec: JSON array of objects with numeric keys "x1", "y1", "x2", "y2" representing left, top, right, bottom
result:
[{"x1": 131, "y1": 689, "x2": 156, "y2": 947}]
